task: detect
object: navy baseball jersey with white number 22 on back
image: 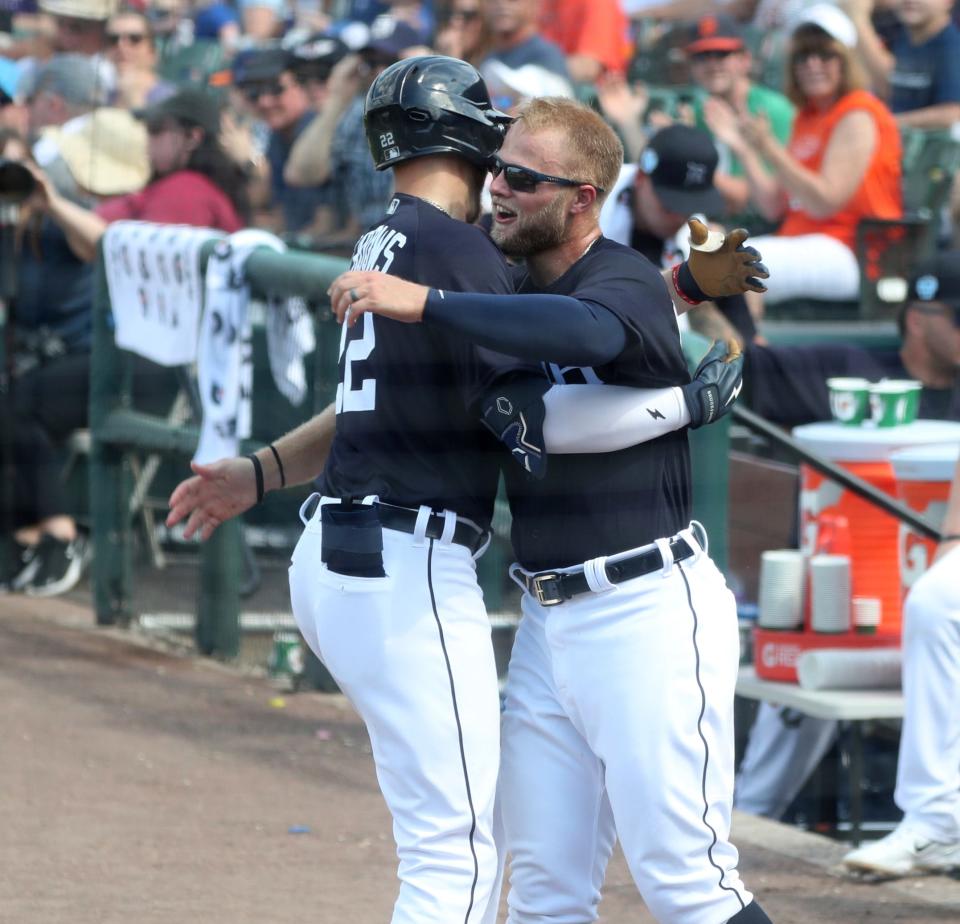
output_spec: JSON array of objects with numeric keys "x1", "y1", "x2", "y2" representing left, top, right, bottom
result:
[{"x1": 318, "y1": 195, "x2": 520, "y2": 527}]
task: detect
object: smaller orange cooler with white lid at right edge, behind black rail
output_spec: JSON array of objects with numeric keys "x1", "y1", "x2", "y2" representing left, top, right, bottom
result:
[{"x1": 890, "y1": 443, "x2": 960, "y2": 597}]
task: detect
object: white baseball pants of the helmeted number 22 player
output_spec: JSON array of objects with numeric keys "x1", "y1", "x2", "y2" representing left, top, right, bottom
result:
[{"x1": 290, "y1": 515, "x2": 499, "y2": 924}]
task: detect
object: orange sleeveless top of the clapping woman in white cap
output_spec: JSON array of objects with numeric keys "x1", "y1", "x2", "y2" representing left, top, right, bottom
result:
[{"x1": 777, "y1": 90, "x2": 903, "y2": 250}]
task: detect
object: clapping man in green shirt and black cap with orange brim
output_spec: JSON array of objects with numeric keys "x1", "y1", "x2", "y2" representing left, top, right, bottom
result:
[{"x1": 685, "y1": 15, "x2": 793, "y2": 234}]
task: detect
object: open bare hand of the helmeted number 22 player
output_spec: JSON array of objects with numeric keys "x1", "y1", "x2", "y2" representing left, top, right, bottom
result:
[{"x1": 167, "y1": 457, "x2": 257, "y2": 542}]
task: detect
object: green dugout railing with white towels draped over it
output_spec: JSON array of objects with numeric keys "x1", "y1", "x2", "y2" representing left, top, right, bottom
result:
[{"x1": 89, "y1": 237, "x2": 729, "y2": 658}]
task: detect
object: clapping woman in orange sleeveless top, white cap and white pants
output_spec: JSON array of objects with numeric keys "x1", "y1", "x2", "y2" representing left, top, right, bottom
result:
[{"x1": 711, "y1": 3, "x2": 903, "y2": 317}]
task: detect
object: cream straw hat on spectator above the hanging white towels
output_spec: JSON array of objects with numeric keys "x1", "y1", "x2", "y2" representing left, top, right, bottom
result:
[{"x1": 43, "y1": 108, "x2": 150, "y2": 196}]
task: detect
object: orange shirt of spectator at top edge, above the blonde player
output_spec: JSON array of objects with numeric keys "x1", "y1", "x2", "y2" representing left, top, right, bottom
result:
[{"x1": 540, "y1": 0, "x2": 632, "y2": 74}]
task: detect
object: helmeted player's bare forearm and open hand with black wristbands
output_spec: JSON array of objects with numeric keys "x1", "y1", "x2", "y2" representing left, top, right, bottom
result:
[{"x1": 166, "y1": 404, "x2": 336, "y2": 540}]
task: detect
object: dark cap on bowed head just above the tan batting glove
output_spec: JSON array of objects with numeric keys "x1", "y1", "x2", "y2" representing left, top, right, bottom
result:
[{"x1": 638, "y1": 125, "x2": 724, "y2": 216}]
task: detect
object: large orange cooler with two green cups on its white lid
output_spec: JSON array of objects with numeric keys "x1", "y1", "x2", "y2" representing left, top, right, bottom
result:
[{"x1": 793, "y1": 420, "x2": 960, "y2": 636}]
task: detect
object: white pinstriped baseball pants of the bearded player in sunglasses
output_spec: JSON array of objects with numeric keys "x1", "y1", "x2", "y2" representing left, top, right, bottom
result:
[{"x1": 500, "y1": 532, "x2": 752, "y2": 924}]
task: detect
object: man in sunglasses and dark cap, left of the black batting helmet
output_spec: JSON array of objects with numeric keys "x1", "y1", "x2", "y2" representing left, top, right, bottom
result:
[{"x1": 233, "y1": 46, "x2": 336, "y2": 231}]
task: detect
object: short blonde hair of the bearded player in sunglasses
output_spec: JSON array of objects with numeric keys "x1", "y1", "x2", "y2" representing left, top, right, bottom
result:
[{"x1": 515, "y1": 96, "x2": 623, "y2": 204}]
